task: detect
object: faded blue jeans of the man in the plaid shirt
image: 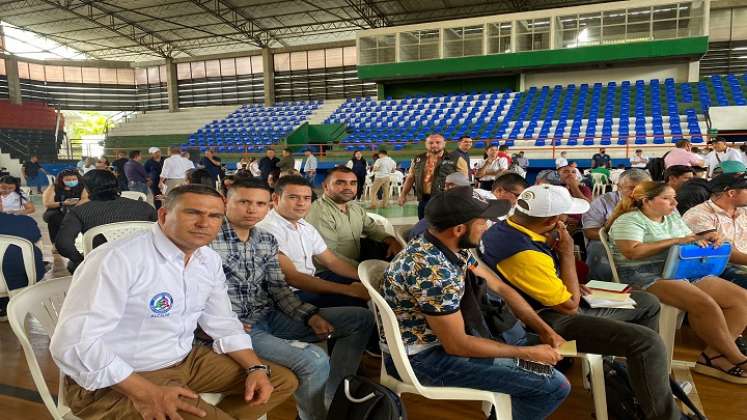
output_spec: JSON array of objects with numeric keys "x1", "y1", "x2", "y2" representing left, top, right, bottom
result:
[{"x1": 249, "y1": 308, "x2": 374, "y2": 420}]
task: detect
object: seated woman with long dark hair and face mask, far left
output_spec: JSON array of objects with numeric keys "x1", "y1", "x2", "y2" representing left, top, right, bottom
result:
[{"x1": 42, "y1": 169, "x2": 88, "y2": 242}]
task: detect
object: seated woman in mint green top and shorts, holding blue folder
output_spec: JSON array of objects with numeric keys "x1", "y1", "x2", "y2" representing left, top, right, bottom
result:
[{"x1": 607, "y1": 181, "x2": 747, "y2": 384}]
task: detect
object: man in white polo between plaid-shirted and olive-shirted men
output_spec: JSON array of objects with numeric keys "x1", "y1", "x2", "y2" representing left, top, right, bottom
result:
[{"x1": 257, "y1": 175, "x2": 369, "y2": 308}]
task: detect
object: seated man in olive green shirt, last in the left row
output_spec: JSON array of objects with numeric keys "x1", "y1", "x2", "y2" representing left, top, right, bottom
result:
[{"x1": 304, "y1": 166, "x2": 402, "y2": 278}]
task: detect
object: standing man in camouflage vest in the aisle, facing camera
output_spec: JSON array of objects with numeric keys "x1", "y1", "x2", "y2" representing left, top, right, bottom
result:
[{"x1": 399, "y1": 134, "x2": 469, "y2": 219}]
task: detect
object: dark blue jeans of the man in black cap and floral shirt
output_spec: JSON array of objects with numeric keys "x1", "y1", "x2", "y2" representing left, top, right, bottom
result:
[{"x1": 384, "y1": 346, "x2": 571, "y2": 420}]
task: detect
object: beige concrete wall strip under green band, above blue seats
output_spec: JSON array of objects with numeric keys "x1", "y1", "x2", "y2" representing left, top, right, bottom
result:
[{"x1": 524, "y1": 63, "x2": 689, "y2": 89}]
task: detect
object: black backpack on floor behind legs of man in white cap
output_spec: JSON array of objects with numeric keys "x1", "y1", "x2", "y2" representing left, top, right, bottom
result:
[{"x1": 604, "y1": 358, "x2": 706, "y2": 420}]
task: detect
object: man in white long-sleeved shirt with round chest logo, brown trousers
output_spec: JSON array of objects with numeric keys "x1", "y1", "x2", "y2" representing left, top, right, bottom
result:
[{"x1": 50, "y1": 185, "x2": 298, "y2": 420}]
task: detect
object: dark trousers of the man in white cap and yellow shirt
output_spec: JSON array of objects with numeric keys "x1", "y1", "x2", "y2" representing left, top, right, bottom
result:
[{"x1": 540, "y1": 291, "x2": 680, "y2": 420}]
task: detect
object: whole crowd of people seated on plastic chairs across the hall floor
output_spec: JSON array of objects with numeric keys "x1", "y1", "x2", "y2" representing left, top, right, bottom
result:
[{"x1": 0, "y1": 135, "x2": 747, "y2": 420}]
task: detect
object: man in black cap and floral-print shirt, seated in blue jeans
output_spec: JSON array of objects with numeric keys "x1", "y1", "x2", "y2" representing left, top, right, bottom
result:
[{"x1": 382, "y1": 187, "x2": 570, "y2": 419}]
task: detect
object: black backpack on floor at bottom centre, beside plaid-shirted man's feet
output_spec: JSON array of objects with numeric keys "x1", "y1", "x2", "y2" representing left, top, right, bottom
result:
[{"x1": 327, "y1": 375, "x2": 407, "y2": 420}]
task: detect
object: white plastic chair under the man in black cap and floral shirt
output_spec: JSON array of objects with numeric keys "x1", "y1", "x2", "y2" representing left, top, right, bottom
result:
[{"x1": 358, "y1": 260, "x2": 511, "y2": 420}]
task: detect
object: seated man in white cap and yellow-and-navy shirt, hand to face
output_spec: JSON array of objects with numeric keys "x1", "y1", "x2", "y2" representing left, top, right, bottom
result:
[{"x1": 480, "y1": 185, "x2": 681, "y2": 420}]
